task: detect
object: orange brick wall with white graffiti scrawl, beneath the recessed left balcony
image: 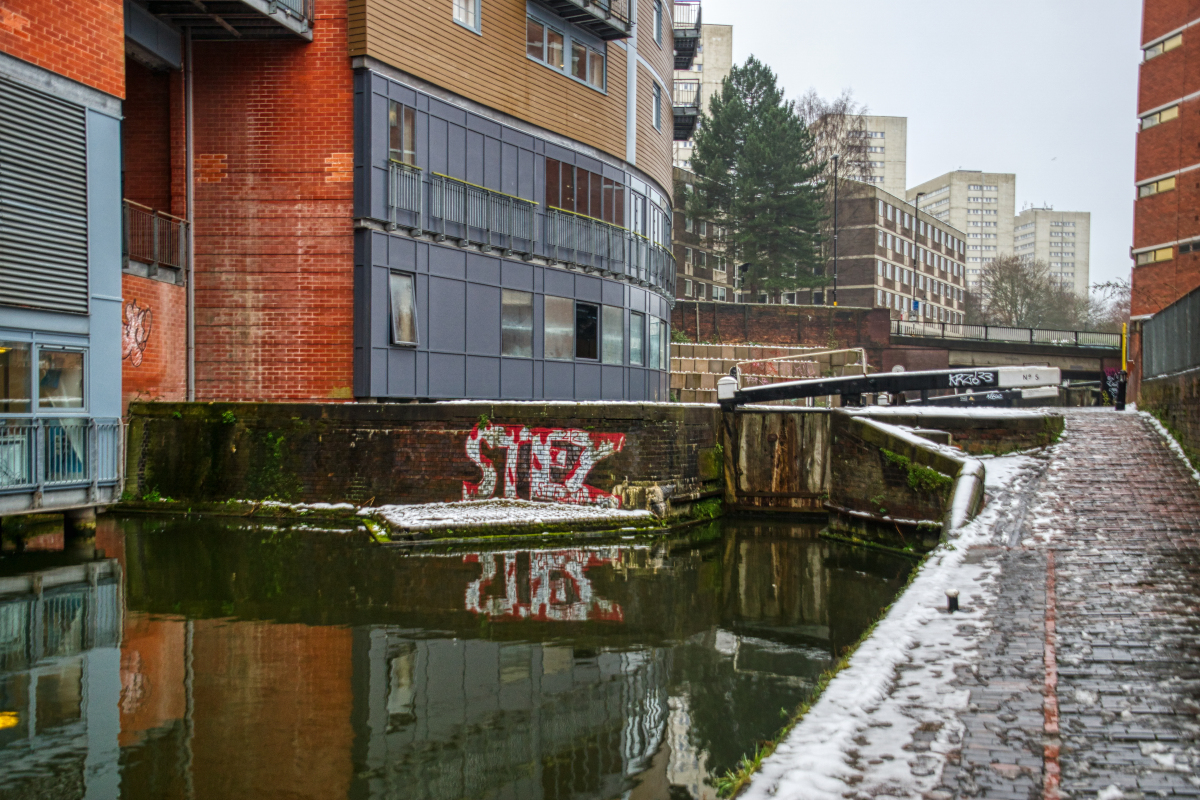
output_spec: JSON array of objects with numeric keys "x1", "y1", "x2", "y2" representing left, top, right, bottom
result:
[{"x1": 121, "y1": 275, "x2": 187, "y2": 410}]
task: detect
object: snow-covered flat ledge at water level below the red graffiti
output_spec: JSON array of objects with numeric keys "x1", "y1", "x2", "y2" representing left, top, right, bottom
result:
[{"x1": 359, "y1": 499, "x2": 652, "y2": 531}]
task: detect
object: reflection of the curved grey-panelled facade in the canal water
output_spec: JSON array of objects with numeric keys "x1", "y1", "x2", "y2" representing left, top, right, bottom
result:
[{"x1": 355, "y1": 628, "x2": 670, "y2": 800}]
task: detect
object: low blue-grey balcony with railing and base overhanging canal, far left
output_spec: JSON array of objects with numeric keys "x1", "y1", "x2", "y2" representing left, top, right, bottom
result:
[{"x1": 0, "y1": 417, "x2": 122, "y2": 515}]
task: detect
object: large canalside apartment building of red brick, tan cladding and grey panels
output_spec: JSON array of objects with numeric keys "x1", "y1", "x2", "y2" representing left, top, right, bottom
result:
[{"x1": 14, "y1": 0, "x2": 700, "y2": 407}]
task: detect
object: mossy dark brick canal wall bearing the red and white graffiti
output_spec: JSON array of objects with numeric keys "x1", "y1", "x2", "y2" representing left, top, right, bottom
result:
[{"x1": 126, "y1": 403, "x2": 721, "y2": 513}]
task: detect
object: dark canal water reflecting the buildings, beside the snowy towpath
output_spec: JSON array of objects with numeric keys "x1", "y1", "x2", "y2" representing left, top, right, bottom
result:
[{"x1": 0, "y1": 517, "x2": 912, "y2": 800}]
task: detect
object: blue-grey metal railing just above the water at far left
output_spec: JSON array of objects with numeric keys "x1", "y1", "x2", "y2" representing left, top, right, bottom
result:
[{"x1": 0, "y1": 417, "x2": 121, "y2": 492}]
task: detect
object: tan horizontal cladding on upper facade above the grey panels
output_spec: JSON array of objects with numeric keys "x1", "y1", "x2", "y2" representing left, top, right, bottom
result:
[{"x1": 349, "y1": 0, "x2": 628, "y2": 165}]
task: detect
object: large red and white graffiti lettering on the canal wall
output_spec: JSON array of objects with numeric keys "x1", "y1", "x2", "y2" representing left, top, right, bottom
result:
[{"x1": 462, "y1": 422, "x2": 625, "y2": 509}]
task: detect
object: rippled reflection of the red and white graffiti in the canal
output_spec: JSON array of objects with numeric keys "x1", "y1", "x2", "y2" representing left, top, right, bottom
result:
[{"x1": 463, "y1": 547, "x2": 625, "y2": 622}]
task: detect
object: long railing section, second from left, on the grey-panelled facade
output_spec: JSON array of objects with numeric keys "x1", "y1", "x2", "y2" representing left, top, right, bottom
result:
[{"x1": 430, "y1": 173, "x2": 538, "y2": 252}]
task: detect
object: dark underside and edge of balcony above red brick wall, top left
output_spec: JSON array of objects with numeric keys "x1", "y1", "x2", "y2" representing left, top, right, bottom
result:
[{"x1": 144, "y1": 0, "x2": 316, "y2": 42}]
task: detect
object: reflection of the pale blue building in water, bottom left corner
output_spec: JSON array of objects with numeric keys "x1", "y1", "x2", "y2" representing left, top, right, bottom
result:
[{"x1": 0, "y1": 559, "x2": 122, "y2": 799}]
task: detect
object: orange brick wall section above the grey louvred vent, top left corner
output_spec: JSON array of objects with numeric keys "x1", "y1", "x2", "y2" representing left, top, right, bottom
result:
[{"x1": 0, "y1": 0, "x2": 125, "y2": 97}]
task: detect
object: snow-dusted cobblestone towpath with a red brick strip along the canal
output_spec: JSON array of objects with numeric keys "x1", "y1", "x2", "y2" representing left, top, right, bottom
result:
[{"x1": 746, "y1": 410, "x2": 1200, "y2": 800}]
